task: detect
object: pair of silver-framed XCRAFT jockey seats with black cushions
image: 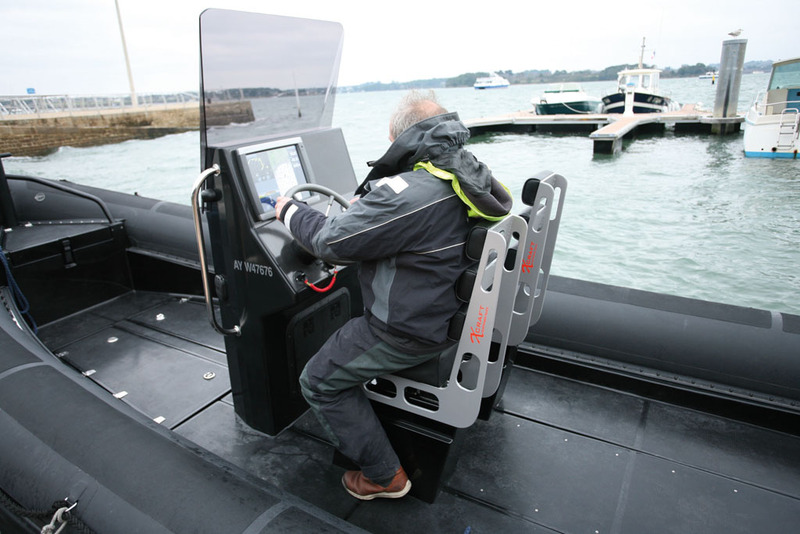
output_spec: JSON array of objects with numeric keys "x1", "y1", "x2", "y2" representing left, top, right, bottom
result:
[{"x1": 364, "y1": 171, "x2": 567, "y2": 428}]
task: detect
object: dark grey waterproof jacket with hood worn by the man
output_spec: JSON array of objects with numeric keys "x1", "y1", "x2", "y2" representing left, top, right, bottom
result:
[{"x1": 281, "y1": 113, "x2": 511, "y2": 345}]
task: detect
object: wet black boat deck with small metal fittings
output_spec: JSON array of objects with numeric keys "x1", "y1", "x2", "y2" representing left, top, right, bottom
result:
[{"x1": 40, "y1": 292, "x2": 800, "y2": 534}]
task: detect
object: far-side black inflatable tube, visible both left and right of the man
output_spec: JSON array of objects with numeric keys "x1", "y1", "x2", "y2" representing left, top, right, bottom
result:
[{"x1": 11, "y1": 178, "x2": 800, "y2": 409}]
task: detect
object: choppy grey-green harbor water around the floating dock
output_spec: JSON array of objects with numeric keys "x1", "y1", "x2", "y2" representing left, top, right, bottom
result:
[{"x1": 6, "y1": 74, "x2": 800, "y2": 314}]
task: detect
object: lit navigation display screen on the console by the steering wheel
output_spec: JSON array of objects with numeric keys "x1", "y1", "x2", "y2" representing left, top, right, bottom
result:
[{"x1": 234, "y1": 141, "x2": 312, "y2": 219}]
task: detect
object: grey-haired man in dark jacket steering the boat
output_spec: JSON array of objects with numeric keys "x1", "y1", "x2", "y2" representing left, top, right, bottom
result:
[{"x1": 276, "y1": 92, "x2": 511, "y2": 500}]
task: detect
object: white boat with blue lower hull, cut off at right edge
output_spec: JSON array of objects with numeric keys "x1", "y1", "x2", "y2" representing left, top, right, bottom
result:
[{"x1": 744, "y1": 57, "x2": 800, "y2": 159}]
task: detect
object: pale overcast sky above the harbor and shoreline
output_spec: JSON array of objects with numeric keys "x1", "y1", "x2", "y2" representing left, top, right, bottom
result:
[{"x1": 0, "y1": 0, "x2": 800, "y2": 95}]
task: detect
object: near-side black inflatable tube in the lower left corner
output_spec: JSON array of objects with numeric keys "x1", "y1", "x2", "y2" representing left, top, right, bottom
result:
[{"x1": 0, "y1": 300, "x2": 354, "y2": 533}]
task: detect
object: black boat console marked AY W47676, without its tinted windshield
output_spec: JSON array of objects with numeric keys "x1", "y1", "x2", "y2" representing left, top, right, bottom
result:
[{"x1": 195, "y1": 129, "x2": 361, "y2": 428}]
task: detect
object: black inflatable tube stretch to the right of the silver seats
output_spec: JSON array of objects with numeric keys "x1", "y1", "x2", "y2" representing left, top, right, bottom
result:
[{"x1": 527, "y1": 276, "x2": 800, "y2": 409}]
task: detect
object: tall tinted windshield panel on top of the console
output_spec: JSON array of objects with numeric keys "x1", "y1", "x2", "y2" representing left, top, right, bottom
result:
[{"x1": 200, "y1": 9, "x2": 343, "y2": 168}]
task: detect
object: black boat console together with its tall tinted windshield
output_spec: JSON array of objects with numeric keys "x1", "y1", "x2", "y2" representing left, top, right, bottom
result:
[{"x1": 192, "y1": 9, "x2": 354, "y2": 435}]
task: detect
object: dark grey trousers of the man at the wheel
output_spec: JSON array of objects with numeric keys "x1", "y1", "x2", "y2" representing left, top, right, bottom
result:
[{"x1": 300, "y1": 317, "x2": 439, "y2": 485}]
